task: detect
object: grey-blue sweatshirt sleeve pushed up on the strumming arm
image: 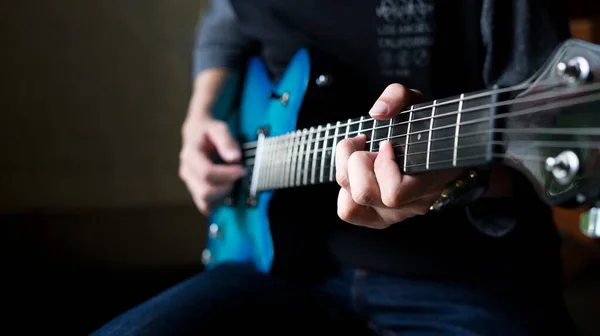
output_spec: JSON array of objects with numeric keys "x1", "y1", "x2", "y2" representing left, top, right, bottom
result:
[{"x1": 193, "y1": 0, "x2": 250, "y2": 77}]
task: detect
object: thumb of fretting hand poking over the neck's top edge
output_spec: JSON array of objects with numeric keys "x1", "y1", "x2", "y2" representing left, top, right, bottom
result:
[{"x1": 369, "y1": 84, "x2": 423, "y2": 120}]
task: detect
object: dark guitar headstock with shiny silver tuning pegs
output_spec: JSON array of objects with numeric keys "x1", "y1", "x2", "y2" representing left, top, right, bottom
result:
[{"x1": 498, "y1": 40, "x2": 600, "y2": 205}]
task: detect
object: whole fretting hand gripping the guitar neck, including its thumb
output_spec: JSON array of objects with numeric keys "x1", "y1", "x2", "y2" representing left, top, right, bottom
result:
[{"x1": 336, "y1": 84, "x2": 462, "y2": 229}]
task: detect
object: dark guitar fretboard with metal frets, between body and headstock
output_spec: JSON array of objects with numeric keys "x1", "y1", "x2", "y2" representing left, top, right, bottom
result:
[{"x1": 247, "y1": 93, "x2": 495, "y2": 191}]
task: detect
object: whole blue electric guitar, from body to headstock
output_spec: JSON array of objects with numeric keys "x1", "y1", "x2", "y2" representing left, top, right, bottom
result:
[{"x1": 203, "y1": 40, "x2": 600, "y2": 272}]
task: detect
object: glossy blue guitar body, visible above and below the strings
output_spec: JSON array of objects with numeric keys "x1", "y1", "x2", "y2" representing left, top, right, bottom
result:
[{"x1": 203, "y1": 50, "x2": 311, "y2": 273}]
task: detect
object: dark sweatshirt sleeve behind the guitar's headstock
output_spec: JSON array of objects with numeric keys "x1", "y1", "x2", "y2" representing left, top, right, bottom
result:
[{"x1": 481, "y1": 0, "x2": 570, "y2": 86}]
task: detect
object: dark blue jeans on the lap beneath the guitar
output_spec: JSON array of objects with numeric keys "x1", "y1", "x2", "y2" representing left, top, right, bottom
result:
[{"x1": 92, "y1": 264, "x2": 570, "y2": 336}]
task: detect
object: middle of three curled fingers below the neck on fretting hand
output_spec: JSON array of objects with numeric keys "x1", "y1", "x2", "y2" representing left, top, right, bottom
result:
[{"x1": 348, "y1": 151, "x2": 383, "y2": 207}]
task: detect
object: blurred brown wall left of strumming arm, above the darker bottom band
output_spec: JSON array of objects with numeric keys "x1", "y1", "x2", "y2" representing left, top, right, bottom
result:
[{"x1": 0, "y1": 0, "x2": 206, "y2": 210}]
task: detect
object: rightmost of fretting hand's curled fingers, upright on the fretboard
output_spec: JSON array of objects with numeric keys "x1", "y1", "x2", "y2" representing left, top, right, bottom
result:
[{"x1": 373, "y1": 141, "x2": 403, "y2": 208}]
